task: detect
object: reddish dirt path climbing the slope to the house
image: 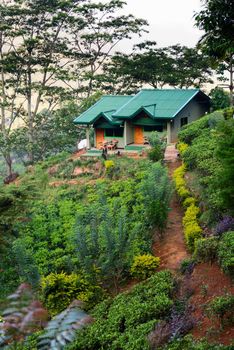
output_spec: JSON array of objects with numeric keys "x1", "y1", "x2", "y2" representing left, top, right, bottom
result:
[{"x1": 153, "y1": 145, "x2": 189, "y2": 271}]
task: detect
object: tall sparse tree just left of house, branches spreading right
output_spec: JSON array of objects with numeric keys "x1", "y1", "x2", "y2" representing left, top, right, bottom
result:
[{"x1": 68, "y1": 0, "x2": 147, "y2": 96}]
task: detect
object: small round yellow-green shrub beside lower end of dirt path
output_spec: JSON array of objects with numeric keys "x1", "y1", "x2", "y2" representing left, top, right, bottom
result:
[{"x1": 130, "y1": 254, "x2": 160, "y2": 279}]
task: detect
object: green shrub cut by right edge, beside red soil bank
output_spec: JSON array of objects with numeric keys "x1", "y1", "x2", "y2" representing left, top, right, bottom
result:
[{"x1": 218, "y1": 231, "x2": 234, "y2": 277}]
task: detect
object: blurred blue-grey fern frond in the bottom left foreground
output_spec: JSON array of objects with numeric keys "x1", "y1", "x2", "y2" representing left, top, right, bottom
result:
[{"x1": 38, "y1": 300, "x2": 92, "y2": 350}]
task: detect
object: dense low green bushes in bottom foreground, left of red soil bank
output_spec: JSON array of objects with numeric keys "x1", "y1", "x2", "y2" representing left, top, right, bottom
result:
[{"x1": 70, "y1": 271, "x2": 173, "y2": 350}]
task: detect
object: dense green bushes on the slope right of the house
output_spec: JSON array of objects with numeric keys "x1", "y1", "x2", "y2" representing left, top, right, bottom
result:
[{"x1": 179, "y1": 110, "x2": 234, "y2": 213}]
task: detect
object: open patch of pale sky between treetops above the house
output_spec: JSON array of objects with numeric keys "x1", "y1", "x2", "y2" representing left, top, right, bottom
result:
[{"x1": 103, "y1": 0, "x2": 205, "y2": 50}]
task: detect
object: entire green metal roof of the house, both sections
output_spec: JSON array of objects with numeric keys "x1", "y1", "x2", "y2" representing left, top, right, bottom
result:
[{"x1": 74, "y1": 89, "x2": 209, "y2": 126}]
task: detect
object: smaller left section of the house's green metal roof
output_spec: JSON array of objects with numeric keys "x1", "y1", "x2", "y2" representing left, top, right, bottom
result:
[{"x1": 74, "y1": 95, "x2": 132, "y2": 125}]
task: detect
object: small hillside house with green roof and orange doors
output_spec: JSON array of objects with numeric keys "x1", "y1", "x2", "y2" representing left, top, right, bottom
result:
[{"x1": 74, "y1": 89, "x2": 210, "y2": 148}]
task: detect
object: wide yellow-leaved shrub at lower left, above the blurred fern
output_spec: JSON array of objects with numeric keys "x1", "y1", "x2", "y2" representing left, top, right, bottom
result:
[{"x1": 41, "y1": 273, "x2": 102, "y2": 315}]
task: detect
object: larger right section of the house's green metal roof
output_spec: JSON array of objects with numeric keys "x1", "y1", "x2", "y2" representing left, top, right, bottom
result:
[{"x1": 112, "y1": 89, "x2": 208, "y2": 119}]
